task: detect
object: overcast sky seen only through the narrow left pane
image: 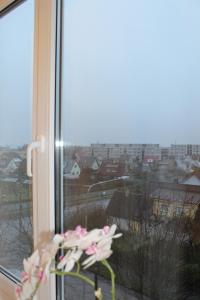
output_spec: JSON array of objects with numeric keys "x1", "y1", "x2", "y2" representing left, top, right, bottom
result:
[{"x1": 0, "y1": 0, "x2": 34, "y2": 146}]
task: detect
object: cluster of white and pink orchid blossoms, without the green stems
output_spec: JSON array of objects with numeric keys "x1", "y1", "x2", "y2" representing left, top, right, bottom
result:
[{"x1": 16, "y1": 225, "x2": 121, "y2": 300}]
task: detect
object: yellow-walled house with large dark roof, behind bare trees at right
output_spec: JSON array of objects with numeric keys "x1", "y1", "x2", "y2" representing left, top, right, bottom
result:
[{"x1": 106, "y1": 183, "x2": 200, "y2": 233}]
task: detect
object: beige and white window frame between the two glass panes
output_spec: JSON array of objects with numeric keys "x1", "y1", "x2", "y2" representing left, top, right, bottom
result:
[{"x1": 0, "y1": 0, "x2": 56, "y2": 300}]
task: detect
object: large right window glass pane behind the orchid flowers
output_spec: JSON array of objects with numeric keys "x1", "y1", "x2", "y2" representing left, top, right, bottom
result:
[{"x1": 62, "y1": 0, "x2": 200, "y2": 300}]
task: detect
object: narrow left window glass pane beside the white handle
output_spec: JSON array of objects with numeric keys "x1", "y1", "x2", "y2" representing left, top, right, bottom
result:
[{"x1": 0, "y1": 0, "x2": 34, "y2": 276}]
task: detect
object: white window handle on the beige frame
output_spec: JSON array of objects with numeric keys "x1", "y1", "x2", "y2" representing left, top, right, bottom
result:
[{"x1": 26, "y1": 136, "x2": 45, "y2": 177}]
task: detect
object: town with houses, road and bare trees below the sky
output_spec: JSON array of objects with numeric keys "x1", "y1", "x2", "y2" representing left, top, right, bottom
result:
[{"x1": 0, "y1": 143, "x2": 200, "y2": 300}]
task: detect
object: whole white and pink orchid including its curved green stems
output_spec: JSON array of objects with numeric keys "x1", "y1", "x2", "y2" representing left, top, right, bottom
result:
[{"x1": 16, "y1": 225, "x2": 122, "y2": 300}]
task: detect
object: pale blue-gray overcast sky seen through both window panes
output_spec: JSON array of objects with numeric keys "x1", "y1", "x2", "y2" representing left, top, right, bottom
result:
[{"x1": 0, "y1": 0, "x2": 200, "y2": 145}]
